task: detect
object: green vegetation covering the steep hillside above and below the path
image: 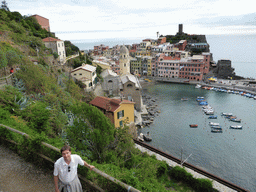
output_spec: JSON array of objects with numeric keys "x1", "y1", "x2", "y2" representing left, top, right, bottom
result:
[{"x1": 0, "y1": 9, "x2": 216, "y2": 192}]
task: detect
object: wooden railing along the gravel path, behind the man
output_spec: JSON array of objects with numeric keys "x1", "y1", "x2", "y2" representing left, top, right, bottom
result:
[{"x1": 0, "y1": 124, "x2": 140, "y2": 192}]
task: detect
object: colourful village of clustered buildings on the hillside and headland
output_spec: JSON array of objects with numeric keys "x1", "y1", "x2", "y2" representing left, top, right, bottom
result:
[{"x1": 23, "y1": 15, "x2": 240, "y2": 135}]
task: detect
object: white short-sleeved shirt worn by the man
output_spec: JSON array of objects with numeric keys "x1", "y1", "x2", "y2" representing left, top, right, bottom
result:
[{"x1": 53, "y1": 155, "x2": 84, "y2": 183}]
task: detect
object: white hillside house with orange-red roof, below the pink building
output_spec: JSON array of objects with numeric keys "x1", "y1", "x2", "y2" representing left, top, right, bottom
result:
[{"x1": 42, "y1": 37, "x2": 66, "y2": 63}]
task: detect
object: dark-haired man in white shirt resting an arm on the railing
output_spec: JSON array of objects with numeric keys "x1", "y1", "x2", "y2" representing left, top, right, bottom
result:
[{"x1": 53, "y1": 145, "x2": 94, "y2": 192}]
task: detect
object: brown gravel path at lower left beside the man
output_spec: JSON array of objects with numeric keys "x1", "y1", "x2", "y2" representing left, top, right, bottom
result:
[{"x1": 0, "y1": 145, "x2": 54, "y2": 192}]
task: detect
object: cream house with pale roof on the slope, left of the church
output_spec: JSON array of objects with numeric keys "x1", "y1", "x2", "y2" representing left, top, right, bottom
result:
[{"x1": 71, "y1": 64, "x2": 97, "y2": 90}]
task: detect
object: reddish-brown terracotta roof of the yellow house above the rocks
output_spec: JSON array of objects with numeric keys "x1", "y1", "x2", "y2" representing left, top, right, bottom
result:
[{"x1": 90, "y1": 97, "x2": 134, "y2": 112}]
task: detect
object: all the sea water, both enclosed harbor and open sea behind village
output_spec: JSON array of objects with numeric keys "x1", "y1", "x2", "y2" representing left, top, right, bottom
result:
[{"x1": 74, "y1": 35, "x2": 256, "y2": 192}]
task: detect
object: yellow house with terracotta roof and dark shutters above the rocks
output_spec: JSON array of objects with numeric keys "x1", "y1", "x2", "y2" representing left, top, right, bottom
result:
[{"x1": 90, "y1": 97, "x2": 134, "y2": 128}]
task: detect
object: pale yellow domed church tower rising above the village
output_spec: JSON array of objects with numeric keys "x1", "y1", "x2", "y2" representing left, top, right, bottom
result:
[{"x1": 119, "y1": 45, "x2": 130, "y2": 75}]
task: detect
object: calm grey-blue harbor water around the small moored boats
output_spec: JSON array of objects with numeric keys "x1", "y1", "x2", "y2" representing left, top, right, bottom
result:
[{"x1": 139, "y1": 83, "x2": 256, "y2": 191}]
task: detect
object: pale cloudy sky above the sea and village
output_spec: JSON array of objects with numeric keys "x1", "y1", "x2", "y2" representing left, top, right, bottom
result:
[{"x1": 6, "y1": 0, "x2": 256, "y2": 41}]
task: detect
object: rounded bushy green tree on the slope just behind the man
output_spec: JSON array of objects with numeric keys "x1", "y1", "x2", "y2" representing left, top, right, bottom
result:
[{"x1": 67, "y1": 103, "x2": 115, "y2": 162}]
